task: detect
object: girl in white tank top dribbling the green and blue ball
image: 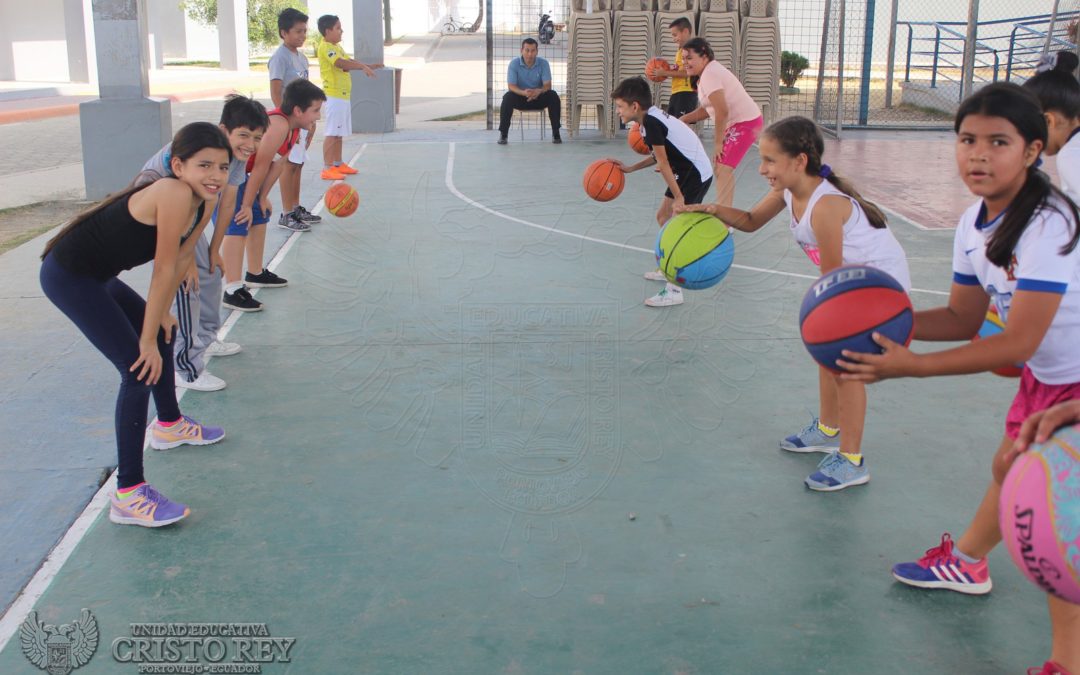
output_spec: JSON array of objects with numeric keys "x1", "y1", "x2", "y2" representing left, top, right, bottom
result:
[{"x1": 686, "y1": 117, "x2": 912, "y2": 491}]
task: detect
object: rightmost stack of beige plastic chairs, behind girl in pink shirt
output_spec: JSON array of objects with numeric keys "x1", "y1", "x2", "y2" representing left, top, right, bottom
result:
[{"x1": 738, "y1": 0, "x2": 780, "y2": 124}]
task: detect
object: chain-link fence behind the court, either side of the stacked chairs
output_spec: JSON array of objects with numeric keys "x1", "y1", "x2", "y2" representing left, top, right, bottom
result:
[{"x1": 486, "y1": 0, "x2": 1080, "y2": 134}]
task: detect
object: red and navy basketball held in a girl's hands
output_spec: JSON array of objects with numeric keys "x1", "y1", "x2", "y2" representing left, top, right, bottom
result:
[{"x1": 799, "y1": 265, "x2": 915, "y2": 373}]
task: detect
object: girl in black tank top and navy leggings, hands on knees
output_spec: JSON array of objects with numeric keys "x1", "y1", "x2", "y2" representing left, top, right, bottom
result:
[{"x1": 41, "y1": 122, "x2": 232, "y2": 527}]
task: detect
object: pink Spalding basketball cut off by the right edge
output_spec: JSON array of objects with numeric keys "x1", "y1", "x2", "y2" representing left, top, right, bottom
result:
[{"x1": 998, "y1": 424, "x2": 1080, "y2": 605}]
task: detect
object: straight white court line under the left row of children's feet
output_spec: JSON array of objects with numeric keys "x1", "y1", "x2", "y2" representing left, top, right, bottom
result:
[{"x1": 0, "y1": 143, "x2": 367, "y2": 651}]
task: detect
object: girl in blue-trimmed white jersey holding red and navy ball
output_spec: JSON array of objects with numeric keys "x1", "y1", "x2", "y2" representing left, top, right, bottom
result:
[{"x1": 840, "y1": 83, "x2": 1080, "y2": 674}]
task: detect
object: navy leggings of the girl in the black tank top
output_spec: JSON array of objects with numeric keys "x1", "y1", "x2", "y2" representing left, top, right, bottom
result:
[{"x1": 41, "y1": 256, "x2": 180, "y2": 489}]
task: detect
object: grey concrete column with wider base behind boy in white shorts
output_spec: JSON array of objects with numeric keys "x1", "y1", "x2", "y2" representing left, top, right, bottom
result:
[{"x1": 351, "y1": 0, "x2": 394, "y2": 133}]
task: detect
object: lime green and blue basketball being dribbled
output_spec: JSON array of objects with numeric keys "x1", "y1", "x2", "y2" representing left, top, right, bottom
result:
[{"x1": 657, "y1": 213, "x2": 735, "y2": 291}]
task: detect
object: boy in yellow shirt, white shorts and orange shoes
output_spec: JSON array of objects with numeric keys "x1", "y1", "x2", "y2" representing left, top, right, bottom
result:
[{"x1": 319, "y1": 14, "x2": 379, "y2": 180}]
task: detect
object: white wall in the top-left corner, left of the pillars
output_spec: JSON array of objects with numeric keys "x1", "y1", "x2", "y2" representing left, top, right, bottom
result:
[{"x1": 0, "y1": 0, "x2": 70, "y2": 82}]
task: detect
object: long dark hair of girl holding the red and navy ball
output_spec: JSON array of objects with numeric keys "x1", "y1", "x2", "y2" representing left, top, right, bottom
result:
[{"x1": 954, "y1": 82, "x2": 1080, "y2": 269}]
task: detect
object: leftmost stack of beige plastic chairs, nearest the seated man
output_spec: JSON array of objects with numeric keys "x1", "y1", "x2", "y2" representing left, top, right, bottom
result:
[{"x1": 566, "y1": 9, "x2": 612, "y2": 136}]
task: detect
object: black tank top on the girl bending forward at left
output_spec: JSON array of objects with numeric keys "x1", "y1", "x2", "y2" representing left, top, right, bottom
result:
[{"x1": 49, "y1": 194, "x2": 206, "y2": 281}]
